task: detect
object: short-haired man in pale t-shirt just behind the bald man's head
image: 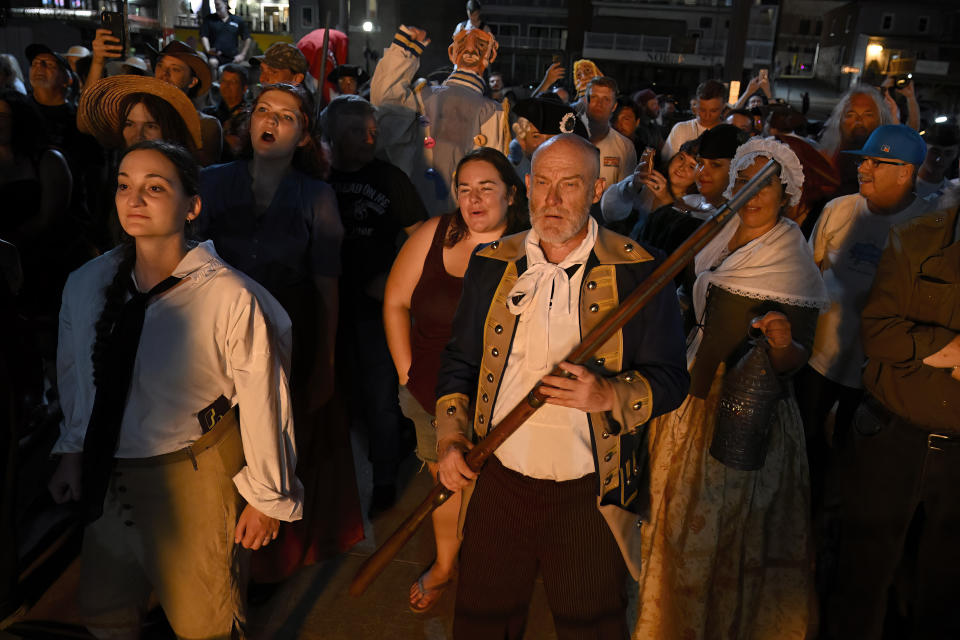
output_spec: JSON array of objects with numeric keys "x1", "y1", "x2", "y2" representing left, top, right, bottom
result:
[{"x1": 584, "y1": 76, "x2": 637, "y2": 189}]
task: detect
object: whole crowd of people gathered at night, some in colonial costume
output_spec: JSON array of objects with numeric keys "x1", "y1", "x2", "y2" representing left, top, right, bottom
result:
[{"x1": 0, "y1": 0, "x2": 960, "y2": 640}]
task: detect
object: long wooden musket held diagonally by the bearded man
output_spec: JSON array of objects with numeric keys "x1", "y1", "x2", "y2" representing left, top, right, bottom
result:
[{"x1": 350, "y1": 160, "x2": 777, "y2": 596}]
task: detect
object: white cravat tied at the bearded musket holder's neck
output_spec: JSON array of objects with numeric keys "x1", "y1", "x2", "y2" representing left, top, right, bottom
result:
[{"x1": 507, "y1": 218, "x2": 597, "y2": 369}]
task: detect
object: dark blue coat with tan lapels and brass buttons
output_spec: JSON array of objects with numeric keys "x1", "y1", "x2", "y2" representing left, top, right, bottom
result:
[{"x1": 436, "y1": 227, "x2": 690, "y2": 575}]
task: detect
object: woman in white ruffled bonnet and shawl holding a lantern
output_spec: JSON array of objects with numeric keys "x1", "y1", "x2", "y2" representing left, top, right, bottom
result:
[{"x1": 634, "y1": 138, "x2": 827, "y2": 639}]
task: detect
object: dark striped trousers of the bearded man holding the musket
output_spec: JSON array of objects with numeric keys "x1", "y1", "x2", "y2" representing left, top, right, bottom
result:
[{"x1": 453, "y1": 456, "x2": 629, "y2": 640}]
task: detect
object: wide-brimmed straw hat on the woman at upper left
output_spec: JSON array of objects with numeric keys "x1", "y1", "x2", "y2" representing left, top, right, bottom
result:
[{"x1": 77, "y1": 75, "x2": 203, "y2": 149}]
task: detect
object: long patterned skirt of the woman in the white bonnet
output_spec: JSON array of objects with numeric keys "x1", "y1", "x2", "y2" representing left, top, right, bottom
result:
[{"x1": 633, "y1": 367, "x2": 816, "y2": 640}]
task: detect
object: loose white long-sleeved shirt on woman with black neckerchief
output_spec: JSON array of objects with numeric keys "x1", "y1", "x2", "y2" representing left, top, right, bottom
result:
[{"x1": 53, "y1": 241, "x2": 303, "y2": 521}]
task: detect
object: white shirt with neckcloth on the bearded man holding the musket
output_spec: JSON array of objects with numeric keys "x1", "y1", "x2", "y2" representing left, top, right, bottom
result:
[{"x1": 493, "y1": 218, "x2": 597, "y2": 482}]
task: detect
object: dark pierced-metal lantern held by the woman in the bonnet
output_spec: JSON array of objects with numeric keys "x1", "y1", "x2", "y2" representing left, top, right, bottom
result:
[{"x1": 710, "y1": 332, "x2": 783, "y2": 471}]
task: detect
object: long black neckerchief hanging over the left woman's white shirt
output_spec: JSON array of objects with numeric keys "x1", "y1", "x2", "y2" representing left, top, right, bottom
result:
[{"x1": 81, "y1": 276, "x2": 180, "y2": 522}]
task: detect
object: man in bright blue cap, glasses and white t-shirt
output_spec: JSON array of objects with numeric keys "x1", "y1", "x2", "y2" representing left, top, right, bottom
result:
[{"x1": 795, "y1": 125, "x2": 930, "y2": 505}]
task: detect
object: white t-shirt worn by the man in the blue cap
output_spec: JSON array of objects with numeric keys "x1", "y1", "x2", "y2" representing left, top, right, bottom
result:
[{"x1": 809, "y1": 193, "x2": 930, "y2": 389}]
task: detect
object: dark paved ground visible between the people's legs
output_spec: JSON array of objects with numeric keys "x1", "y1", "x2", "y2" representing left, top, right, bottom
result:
[{"x1": 0, "y1": 424, "x2": 584, "y2": 640}]
